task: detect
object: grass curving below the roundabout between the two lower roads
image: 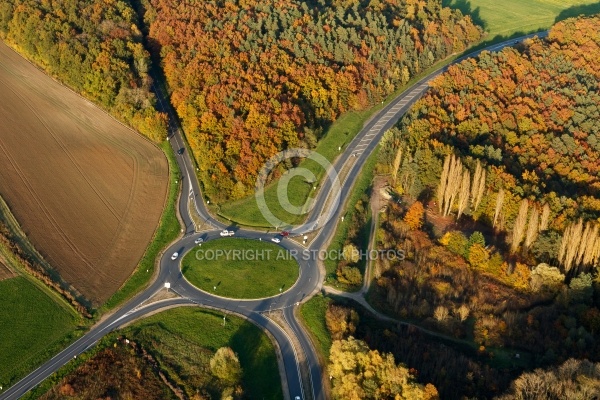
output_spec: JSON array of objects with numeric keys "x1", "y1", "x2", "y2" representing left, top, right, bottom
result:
[{"x1": 124, "y1": 307, "x2": 283, "y2": 399}]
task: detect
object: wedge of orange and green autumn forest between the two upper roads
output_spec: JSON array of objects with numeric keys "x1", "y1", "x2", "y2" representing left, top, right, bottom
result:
[{"x1": 144, "y1": 0, "x2": 481, "y2": 200}]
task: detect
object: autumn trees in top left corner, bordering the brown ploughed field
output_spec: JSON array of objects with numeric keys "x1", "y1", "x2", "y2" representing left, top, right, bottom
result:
[{"x1": 0, "y1": 0, "x2": 167, "y2": 141}]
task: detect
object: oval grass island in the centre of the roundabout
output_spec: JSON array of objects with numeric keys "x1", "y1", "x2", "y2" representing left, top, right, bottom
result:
[{"x1": 181, "y1": 238, "x2": 298, "y2": 299}]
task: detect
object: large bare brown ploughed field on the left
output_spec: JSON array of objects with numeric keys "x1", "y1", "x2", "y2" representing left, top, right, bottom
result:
[{"x1": 0, "y1": 42, "x2": 169, "y2": 305}]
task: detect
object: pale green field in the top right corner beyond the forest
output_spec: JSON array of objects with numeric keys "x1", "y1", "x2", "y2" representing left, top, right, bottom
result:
[{"x1": 442, "y1": 0, "x2": 600, "y2": 42}]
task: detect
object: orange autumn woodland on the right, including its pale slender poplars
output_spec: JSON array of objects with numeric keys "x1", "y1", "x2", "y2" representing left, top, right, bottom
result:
[{"x1": 382, "y1": 16, "x2": 600, "y2": 276}]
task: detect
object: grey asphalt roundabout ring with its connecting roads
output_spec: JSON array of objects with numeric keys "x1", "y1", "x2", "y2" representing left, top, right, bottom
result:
[{"x1": 0, "y1": 32, "x2": 547, "y2": 400}]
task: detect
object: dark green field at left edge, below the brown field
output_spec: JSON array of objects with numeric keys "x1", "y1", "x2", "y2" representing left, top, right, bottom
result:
[{"x1": 0, "y1": 276, "x2": 77, "y2": 387}]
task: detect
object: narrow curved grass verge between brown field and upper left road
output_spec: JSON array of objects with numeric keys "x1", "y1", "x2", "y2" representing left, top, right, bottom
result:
[{"x1": 100, "y1": 142, "x2": 181, "y2": 313}]
